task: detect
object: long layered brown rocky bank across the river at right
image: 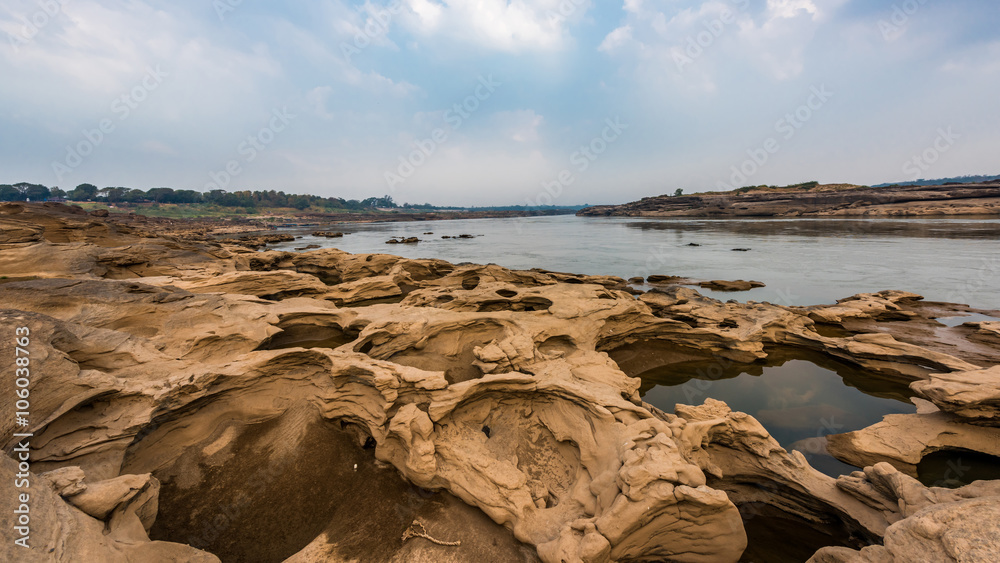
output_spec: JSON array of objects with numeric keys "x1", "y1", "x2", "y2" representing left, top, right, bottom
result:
[{"x1": 577, "y1": 181, "x2": 1000, "y2": 218}]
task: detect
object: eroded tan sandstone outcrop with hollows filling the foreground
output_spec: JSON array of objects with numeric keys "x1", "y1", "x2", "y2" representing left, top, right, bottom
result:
[{"x1": 0, "y1": 205, "x2": 1000, "y2": 563}]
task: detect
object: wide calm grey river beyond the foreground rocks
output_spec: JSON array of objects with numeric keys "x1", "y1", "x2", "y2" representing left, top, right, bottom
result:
[{"x1": 274, "y1": 215, "x2": 1000, "y2": 309}]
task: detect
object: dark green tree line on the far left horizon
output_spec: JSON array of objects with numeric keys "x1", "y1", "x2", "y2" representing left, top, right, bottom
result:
[{"x1": 0, "y1": 182, "x2": 422, "y2": 210}]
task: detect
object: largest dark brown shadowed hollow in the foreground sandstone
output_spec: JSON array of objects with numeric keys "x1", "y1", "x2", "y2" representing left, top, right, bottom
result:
[{"x1": 124, "y1": 405, "x2": 537, "y2": 563}]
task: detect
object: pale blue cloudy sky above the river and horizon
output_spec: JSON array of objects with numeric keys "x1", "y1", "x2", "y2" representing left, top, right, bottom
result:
[{"x1": 0, "y1": 0, "x2": 1000, "y2": 205}]
